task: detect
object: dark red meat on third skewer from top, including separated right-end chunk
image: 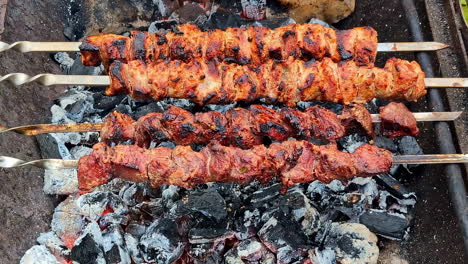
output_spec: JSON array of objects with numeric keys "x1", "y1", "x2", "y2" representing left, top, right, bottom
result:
[{"x1": 100, "y1": 103, "x2": 419, "y2": 149}]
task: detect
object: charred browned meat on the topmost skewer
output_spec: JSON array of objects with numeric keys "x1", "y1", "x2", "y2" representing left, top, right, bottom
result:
[{"x1": 80, "y1": 24, "x2": 378, "y2": 66}]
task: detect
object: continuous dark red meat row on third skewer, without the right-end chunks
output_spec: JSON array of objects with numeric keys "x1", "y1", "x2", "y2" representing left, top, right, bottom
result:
[{"x1": 101, "y1": 105, "x2": 352, "y2": 149}]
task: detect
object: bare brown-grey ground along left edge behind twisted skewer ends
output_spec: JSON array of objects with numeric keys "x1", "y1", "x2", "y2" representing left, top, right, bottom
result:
[{"x1": 0, "y1": 0, "x2": 64, "y2": 263}]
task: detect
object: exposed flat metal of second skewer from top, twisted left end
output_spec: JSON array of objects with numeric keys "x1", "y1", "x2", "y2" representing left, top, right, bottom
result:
[{"x1": 0, "y1": 73, "x2": 468, "y2": 88}]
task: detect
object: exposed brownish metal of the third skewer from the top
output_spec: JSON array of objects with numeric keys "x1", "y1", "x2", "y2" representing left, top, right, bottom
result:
[{"x1": 0, "y1": 112, "x2": 463, "y2": 136}]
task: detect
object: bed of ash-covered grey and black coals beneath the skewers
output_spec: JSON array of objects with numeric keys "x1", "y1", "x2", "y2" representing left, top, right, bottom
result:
[{"x1": 21, "y1": 1, "x2": 422, "y2": 264}]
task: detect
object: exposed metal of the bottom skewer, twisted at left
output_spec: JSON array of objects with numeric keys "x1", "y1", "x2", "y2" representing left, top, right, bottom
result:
[{"x1": 0, "y1": 154, "x2": 468, "y2": 170}]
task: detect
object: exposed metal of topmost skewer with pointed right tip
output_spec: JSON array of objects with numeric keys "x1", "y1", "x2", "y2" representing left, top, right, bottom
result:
[{"x1": 0, "y1": 41, "x2": 449, "y2": 53}]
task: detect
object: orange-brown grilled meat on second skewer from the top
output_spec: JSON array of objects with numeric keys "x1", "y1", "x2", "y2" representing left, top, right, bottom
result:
[{"x1": 106, "y1": 58, "x2": 426, "y2": 106}]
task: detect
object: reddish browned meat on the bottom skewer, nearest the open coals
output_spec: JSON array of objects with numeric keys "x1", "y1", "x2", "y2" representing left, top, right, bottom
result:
[{"x1": 78, "y1": 141, "x2": 392, "y2": 191}]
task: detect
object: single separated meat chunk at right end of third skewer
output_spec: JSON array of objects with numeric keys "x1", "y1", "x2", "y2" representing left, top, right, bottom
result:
[{"x1": 379, "y1": 102, "x2": 419, "y2": 138}]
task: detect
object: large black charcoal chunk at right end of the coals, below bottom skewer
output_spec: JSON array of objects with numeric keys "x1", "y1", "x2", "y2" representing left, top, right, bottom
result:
[{"x1": 359, "y1": 210, "x2": 409, "y2": 240}]
